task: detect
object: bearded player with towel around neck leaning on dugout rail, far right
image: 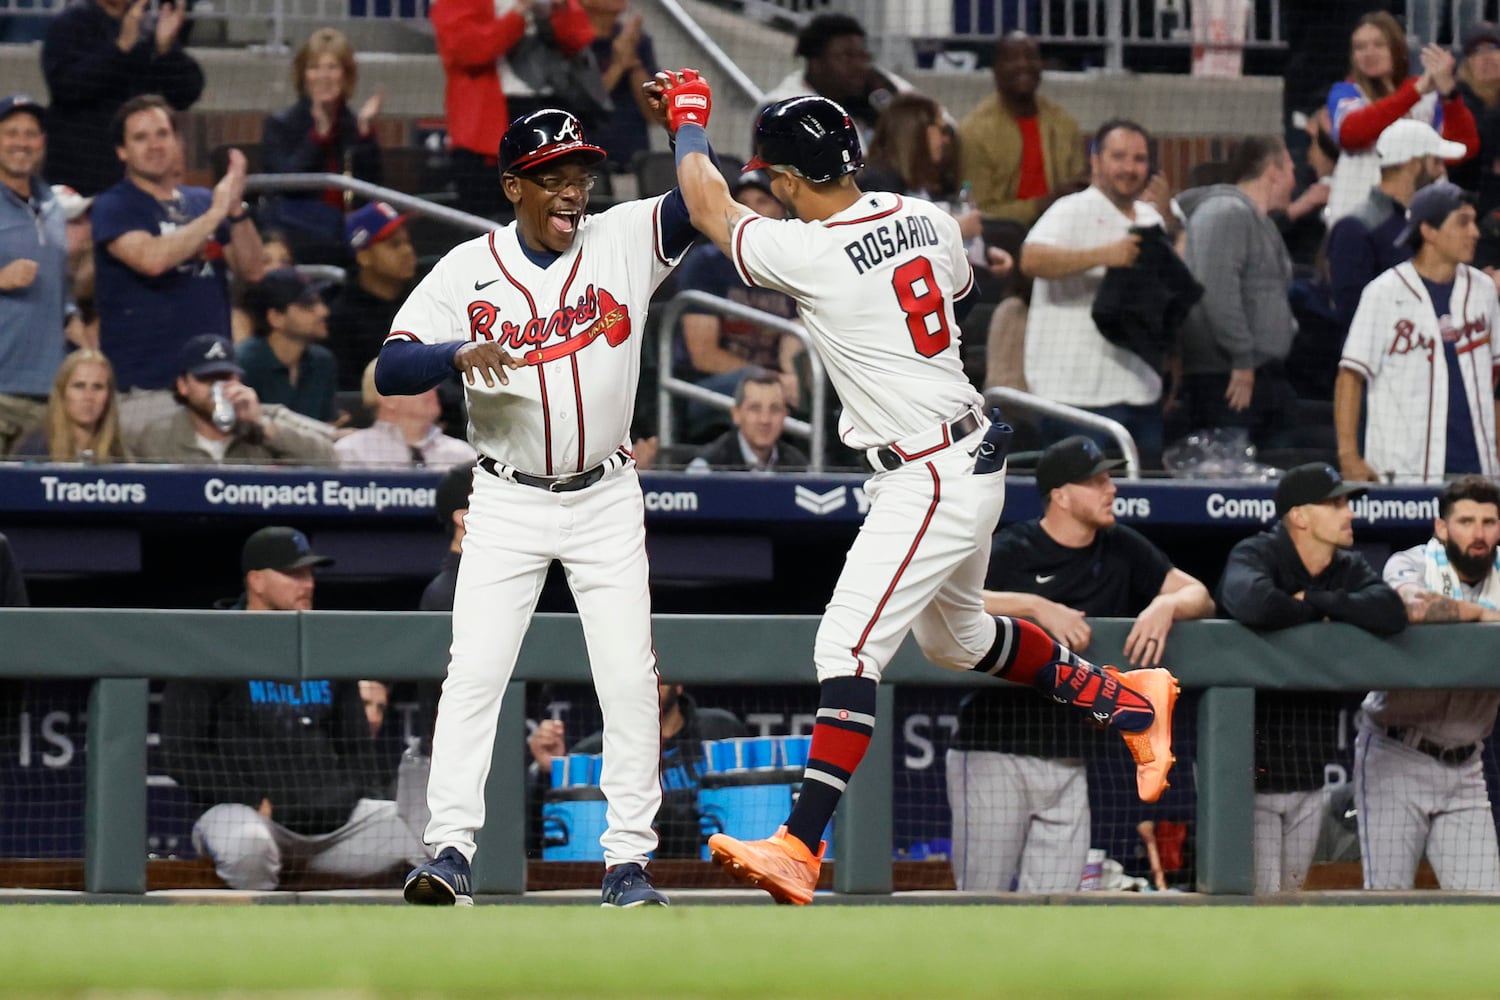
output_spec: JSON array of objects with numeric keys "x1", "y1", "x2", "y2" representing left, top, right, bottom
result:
[{"x1": 1355, "y1": 475, "x2": 1500, "y2": 892}]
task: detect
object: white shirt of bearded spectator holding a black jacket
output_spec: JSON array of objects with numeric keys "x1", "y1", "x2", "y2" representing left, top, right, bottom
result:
[{"x1": 1026, "y1": 187, "x2": 1161, "y2": 408}]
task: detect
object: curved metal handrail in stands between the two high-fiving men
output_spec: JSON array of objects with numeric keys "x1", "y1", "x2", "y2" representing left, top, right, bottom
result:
[{"x1": 657, "y1": 291, "x2": 828, "y2": 472}]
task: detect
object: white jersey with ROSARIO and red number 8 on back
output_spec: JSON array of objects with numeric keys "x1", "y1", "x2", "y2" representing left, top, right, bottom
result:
[{"x1": 731, "y1": 192, "x2": 984, "y2": 448}]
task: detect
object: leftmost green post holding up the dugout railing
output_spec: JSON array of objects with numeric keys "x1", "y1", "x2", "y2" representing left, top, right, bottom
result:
[{"x1": 84, "y1": 679, "x2": 149, "y2": 894}]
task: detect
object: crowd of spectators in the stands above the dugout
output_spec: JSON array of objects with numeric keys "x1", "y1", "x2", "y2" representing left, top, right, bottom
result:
[{"x1": 14, "y1": 0, "x2": 1500, "y2": 481}]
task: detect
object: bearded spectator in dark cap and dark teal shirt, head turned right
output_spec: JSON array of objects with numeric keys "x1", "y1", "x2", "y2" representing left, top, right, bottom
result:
[{"x1": 234, "y1": 267, "x2": 339, "y2": 423}]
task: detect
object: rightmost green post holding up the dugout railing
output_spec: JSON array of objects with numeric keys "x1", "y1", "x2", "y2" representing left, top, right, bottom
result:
[{"x1": 1197, "y1": 688, "x2": 1256, "y2": 895}]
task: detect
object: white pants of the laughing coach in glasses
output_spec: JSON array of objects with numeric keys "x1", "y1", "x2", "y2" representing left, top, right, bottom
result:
[{"x1": 426, "y1": 466, "x2": 662, "y2": 867}]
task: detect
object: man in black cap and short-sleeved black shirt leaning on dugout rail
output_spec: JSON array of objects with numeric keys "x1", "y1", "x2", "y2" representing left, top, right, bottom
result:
[{"x1": 947, "y1": 436, "x2": 1214, "y2": 892}]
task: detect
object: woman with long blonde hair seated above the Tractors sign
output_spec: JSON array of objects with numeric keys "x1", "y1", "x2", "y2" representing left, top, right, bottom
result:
[{"x1": 11, "y1": 348, "x2": 131, "y2": 462}]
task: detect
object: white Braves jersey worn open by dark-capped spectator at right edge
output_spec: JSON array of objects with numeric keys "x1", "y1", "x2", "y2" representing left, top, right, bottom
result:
[{"x1": 1338, "y1": 261, "x2": 1500, "y2": 483}]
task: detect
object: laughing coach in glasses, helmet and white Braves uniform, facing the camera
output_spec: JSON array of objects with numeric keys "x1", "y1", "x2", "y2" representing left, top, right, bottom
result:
[{"x1": 375, "y1": 109, "x2": 695, "y2": 907}]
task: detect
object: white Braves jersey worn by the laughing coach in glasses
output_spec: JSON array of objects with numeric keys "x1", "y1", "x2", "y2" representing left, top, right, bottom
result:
[{"x1": 389, "y1": 198, "x2": 680, "y2": 477}]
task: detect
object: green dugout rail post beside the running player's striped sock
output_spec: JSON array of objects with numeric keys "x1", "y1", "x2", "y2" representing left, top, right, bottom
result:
[{"x1": 834, "y1": 684, "x2": 896, "y2": 895}]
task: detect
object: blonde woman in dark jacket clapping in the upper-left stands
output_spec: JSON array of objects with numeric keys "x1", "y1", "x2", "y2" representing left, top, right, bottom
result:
[{"x1": 257, "y1": 28, "x2": 386, "y2": 264}]
